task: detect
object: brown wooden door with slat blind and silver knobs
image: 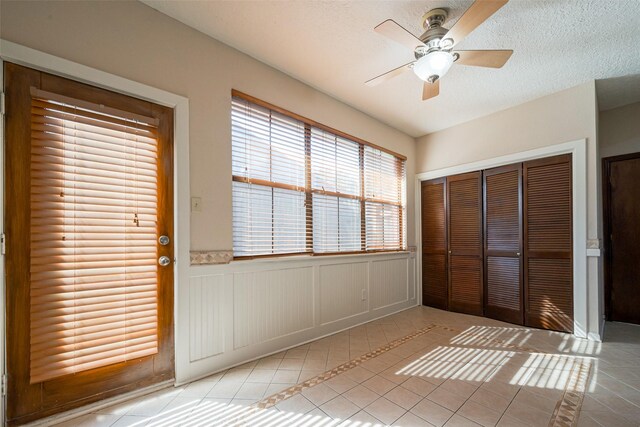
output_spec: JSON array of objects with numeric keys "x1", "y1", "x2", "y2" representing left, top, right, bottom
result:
[{"x1": 4, "y1": 63, "x2": 174, "y2": 425}]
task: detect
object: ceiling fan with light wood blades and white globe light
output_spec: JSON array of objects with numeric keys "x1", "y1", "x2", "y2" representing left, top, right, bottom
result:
[{"x1": 365, "y1": 0, "x2": 513, "y2": 101}]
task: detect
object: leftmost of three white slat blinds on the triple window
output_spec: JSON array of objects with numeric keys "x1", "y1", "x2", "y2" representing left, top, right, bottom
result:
[{"x1": 231, "y1": 98, "x2": 309, "y2": 256}]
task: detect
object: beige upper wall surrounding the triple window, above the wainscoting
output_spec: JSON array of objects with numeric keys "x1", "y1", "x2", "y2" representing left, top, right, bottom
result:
[{"x1": 0, "y1": 0, "x2": 415, "y2": 250}]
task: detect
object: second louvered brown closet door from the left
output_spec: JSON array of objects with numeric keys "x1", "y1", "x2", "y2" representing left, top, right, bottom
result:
[{"x1": 447, "y1": 172, "x2": 483, "y2": 315}]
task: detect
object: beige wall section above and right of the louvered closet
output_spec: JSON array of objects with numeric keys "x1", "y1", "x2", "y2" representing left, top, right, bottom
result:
[{"x1": 416, "y1": 81, "x2": 603, "y2": 339}]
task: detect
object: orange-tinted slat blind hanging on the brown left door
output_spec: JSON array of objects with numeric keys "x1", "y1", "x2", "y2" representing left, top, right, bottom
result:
[{"x1": 30, "y1": 91, "x2": 158, "y2": 383}]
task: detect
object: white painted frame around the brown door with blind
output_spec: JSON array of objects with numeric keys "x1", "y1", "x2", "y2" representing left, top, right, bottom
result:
[{"x1": 0, "y1": 39, "x2": 190, "y2": 422}]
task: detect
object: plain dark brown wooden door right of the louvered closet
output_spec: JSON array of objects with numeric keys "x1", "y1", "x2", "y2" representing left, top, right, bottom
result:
[{"x1": 604, "y1": 153, "x2": 640, "y2": 324}]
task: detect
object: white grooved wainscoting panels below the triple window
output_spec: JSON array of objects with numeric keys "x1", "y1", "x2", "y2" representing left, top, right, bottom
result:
[{"x1": 176, "y1": 252, "x2": 416, "y2": 384}]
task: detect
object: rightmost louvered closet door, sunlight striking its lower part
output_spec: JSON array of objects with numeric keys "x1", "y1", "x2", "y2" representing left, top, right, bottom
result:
[{"x1": 524, "y1": 155, "x2": 573, "y2": 332}]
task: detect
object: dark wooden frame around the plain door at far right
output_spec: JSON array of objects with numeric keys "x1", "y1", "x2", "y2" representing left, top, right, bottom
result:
[{"x1": 602, "y1": 152, "x2": 640, "y2": 320}]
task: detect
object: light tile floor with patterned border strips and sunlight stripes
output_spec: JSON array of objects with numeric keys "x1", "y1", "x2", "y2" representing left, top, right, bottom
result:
[{"x1": 59, "y1": 307, "x2": 640, "y2": 427}]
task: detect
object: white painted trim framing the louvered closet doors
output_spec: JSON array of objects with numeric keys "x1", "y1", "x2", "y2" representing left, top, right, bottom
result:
[{"x1": 414, "y1": 139, "x2": 601, "y2": 341}]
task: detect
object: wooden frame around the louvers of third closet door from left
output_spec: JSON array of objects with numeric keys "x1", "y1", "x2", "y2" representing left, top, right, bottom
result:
[{"x1": 482, "y1": 163, "x2": 525, "y2": 325}]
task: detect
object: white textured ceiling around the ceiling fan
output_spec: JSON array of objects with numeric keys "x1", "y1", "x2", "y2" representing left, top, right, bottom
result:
[{"x1": 143, "y1": 0, "x2": 640, "y2": 137}]
